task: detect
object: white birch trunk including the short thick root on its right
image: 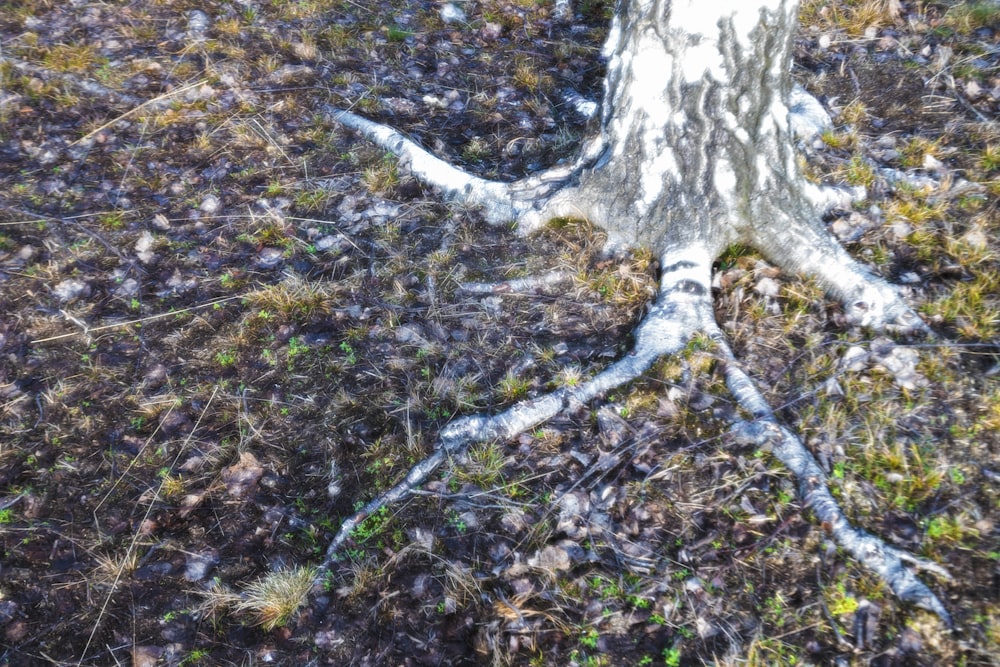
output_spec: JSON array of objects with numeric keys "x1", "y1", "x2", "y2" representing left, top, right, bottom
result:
[{"x1": 530, "y1": 0, "x2": 919, "y2": 329}]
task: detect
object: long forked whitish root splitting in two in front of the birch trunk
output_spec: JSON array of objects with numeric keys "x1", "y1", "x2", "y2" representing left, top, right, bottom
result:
[{"x1": 320, "y1": 243, "x2": 952, "y2": 628}]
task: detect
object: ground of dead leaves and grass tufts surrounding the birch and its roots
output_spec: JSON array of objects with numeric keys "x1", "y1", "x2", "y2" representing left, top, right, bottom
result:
[{"x1": 0, "y1": 0, "x2": 1000, "y2": 667}]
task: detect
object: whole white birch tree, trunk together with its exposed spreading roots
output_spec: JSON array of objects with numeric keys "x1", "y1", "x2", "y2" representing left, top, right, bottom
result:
[{"x1": 328, "y1": 0, "x2": 950, "y2": 623}]
